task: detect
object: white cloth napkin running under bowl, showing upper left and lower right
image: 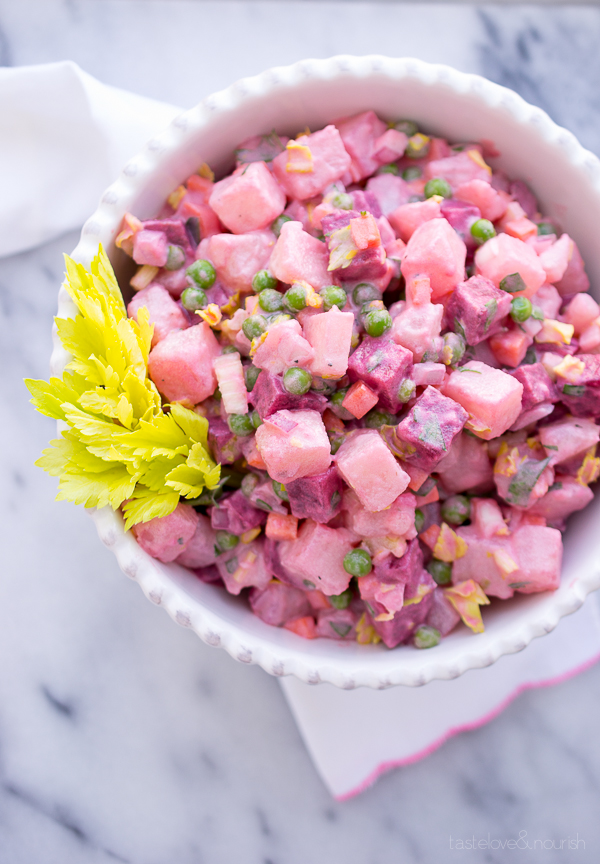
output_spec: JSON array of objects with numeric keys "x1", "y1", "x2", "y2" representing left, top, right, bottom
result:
[{"x1": 5, "y1": 62, "x2": 600, "y2": 798}]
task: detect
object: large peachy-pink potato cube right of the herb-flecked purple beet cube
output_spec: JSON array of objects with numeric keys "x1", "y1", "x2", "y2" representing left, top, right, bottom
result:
[{"x1": 444, "y1": 360, "x2": 523, "y2": 441}]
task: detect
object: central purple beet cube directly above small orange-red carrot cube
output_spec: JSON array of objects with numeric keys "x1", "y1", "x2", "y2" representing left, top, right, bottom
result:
[{"x1": 348, "y1": 336, "x2": 413, "y2": 413}]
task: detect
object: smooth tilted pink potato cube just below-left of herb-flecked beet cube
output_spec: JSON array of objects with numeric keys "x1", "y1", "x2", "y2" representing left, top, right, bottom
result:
[{"x1": 336, "y1": 427, "x2": 410, "y2": 512}]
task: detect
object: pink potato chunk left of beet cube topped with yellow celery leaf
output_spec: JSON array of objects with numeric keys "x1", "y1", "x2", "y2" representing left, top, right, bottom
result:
[{"x1": 269, "y1": 222, "x2": 332, "y2": 290}]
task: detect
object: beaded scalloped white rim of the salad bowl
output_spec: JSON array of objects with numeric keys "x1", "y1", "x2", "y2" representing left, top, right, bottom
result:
[{"x1": 51, "y1": 55, "x2": 600, "y2": 689}]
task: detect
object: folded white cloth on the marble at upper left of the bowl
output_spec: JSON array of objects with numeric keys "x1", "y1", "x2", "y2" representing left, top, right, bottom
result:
[{"x1": 0, "y1": 61, "x2": 181, "y2": 256}]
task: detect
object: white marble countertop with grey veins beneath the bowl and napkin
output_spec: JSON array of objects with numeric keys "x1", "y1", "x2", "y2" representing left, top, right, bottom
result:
[{"x1": 0, "y1": 0, "x2": 600, "y2": 864}]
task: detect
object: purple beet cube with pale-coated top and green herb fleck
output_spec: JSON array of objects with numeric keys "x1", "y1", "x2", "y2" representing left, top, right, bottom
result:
[{"x1": 395, "y1": 387, "x2": 469, "y2": 472}]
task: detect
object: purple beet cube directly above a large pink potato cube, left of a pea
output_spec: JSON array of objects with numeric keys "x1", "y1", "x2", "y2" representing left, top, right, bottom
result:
[{"x1": 446, "y1": 276, "x2": 512, "y2": 345}]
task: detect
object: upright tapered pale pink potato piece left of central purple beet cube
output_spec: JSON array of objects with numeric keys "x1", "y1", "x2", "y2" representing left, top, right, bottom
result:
[{"x1": 303, "y1": 306, "x2": 354, "y2": 379}]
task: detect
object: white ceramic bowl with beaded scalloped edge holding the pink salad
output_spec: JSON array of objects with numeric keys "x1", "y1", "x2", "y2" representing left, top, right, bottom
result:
[{"x1": 52, "y1": 56, "x2": 600, "y2": 688}]
